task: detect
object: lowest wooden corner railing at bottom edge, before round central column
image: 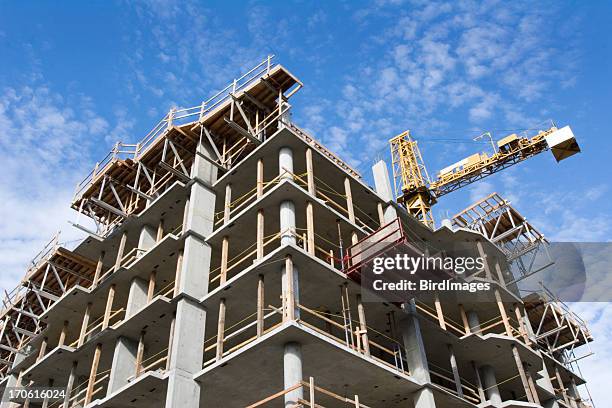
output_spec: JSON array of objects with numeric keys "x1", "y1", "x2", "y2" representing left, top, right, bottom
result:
[{"x1": 246, "y1": 377, "x2": 370, "y2": 408}]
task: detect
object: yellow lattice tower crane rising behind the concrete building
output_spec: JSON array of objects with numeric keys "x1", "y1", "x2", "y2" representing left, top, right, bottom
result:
[{"x1": 389, "y1": 125, "x2": 580, "y2": 228}]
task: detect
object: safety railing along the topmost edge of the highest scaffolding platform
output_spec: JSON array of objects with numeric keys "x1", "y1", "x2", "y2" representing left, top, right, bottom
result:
[{"x1": 74, "y1": 55, "x2": 274, "y2": 202}]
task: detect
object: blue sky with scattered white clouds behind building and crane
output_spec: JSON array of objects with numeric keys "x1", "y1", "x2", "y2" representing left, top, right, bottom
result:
[{"x1": 0, "y1": 0, "x2": 612, "y2": 402}]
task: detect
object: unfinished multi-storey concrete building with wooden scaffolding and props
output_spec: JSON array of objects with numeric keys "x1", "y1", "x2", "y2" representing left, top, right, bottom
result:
[{"x1": 0, "y1": 57, "x2": 592, "y2": 408}]
